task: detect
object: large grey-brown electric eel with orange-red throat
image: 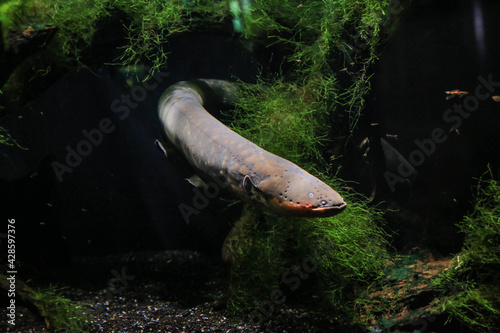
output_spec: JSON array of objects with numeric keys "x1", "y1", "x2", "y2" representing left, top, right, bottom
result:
[{"x1": 158, "y1": 79, "x2": 346, "y2": 217}]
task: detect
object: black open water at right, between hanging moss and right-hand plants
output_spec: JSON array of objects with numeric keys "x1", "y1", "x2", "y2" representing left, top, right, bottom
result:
[{"x1": 369, "y1": 0, "x2": 500, "y2": 250}]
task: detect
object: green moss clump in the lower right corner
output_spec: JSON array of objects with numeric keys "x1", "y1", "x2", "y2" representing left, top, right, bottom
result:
[{"x1": 434, "y1": 172, "x2": 500, "y2": 332}]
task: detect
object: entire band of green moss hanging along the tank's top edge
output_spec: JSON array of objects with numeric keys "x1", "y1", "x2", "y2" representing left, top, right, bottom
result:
[{"x1": 3, "y1": 0, "x2": 390, "y2": 118}]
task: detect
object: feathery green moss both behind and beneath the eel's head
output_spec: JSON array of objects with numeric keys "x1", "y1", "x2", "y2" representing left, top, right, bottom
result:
[{"x1": 229, "y1": 75, "x2": 389, "y2": 320}]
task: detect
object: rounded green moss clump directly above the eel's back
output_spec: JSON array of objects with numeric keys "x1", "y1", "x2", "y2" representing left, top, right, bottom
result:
[{"x1": 230, "y1": 80, "x2": 329, "y2": 171}]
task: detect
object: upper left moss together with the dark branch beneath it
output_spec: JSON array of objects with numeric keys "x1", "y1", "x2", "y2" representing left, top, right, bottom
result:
[{"x1": 0, "y1": 0, "x2": 230, "y2": 113}]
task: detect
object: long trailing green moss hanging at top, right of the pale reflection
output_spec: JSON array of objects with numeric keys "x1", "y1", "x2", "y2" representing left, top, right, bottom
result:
[{"x1": 236, "y1": 0, "x2": 390, "y2": 133}]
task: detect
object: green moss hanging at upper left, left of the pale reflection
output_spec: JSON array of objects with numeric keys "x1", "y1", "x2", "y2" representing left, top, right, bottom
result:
[{"x1": 0, "y1": 0, "x2": 229, "y2": 72}]
